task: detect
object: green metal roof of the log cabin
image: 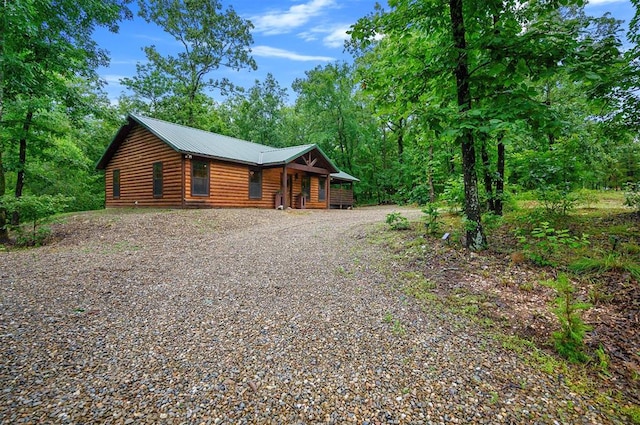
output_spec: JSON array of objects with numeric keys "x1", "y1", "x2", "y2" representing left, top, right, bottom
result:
[{"x1": 97, "y1": 114, "x2": 348, "y2": 174}]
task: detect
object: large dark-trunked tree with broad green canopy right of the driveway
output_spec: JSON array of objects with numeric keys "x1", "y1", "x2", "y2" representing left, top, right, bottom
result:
[{"x1": 350, "y1": 0, "x2": 632, "y2": 249}]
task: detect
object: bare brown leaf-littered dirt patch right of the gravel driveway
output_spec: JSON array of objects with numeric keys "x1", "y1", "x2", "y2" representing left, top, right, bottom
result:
[{"x1": 385, "y1": 225, "x2": 640, "y2": 403}]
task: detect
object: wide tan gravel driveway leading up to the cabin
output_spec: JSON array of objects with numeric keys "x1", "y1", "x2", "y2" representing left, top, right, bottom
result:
[{"x1": 0, "y1": 208, "x2": 624, "y2": 424}]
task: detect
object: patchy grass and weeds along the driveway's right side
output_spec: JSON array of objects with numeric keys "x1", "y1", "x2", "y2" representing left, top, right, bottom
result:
[{"x1": 370, "y1": 192, "x2": 640, "y2": 424}]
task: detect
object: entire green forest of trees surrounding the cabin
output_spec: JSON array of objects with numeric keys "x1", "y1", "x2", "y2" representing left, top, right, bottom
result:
[{"x1": 0, "y1": 0, "x2": 640, "y2": 249}]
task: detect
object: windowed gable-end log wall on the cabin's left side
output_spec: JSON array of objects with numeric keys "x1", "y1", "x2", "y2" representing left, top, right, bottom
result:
[{"x1": 105, "y1": 125, "x2": 182, "y2": 207}]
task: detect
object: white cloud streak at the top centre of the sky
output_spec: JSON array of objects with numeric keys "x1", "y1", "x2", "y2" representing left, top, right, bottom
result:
[{"x1": 250, "y1": 0, "x2": 337, "y2": 35}]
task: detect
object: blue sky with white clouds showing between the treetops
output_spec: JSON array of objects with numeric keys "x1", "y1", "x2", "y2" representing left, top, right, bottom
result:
[{"x1": 95, "y1": 0, "x2": 634, "y2": 100}]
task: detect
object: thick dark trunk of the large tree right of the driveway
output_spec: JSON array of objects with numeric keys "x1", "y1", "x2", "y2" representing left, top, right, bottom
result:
[{"x1": 449, "y1": 0, "x2": 487, "y2": 251}]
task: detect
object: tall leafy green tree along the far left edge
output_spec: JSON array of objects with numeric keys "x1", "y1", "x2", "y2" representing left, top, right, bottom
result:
[{"x1": 0, "y1": 0, "x2": 130, "y2": 238}]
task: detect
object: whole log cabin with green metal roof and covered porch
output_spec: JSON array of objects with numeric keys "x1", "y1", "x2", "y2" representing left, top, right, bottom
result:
[{"x1": 96, "y1": 114, "x2": 358, "y2": 209}]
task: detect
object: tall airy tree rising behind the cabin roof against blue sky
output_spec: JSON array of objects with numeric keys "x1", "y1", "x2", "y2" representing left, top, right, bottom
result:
[{"x1": 131, "y1": 0, "x2": 257, "y2": 126}]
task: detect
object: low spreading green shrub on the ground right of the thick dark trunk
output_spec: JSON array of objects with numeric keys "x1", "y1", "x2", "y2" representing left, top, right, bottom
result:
[{"x1": 518, "y1": 221, "x2": 589, "y2": 266}]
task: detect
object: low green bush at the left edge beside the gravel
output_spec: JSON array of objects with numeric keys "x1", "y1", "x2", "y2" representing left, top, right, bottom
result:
[{"x1": 0, "y1": 195, "x2": 72, "y2": 246}]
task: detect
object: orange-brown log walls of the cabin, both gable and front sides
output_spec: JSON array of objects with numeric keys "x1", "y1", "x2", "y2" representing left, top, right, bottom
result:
[{"x1": 105, "y1": 125, "x2": 331, "y2": 209}]
